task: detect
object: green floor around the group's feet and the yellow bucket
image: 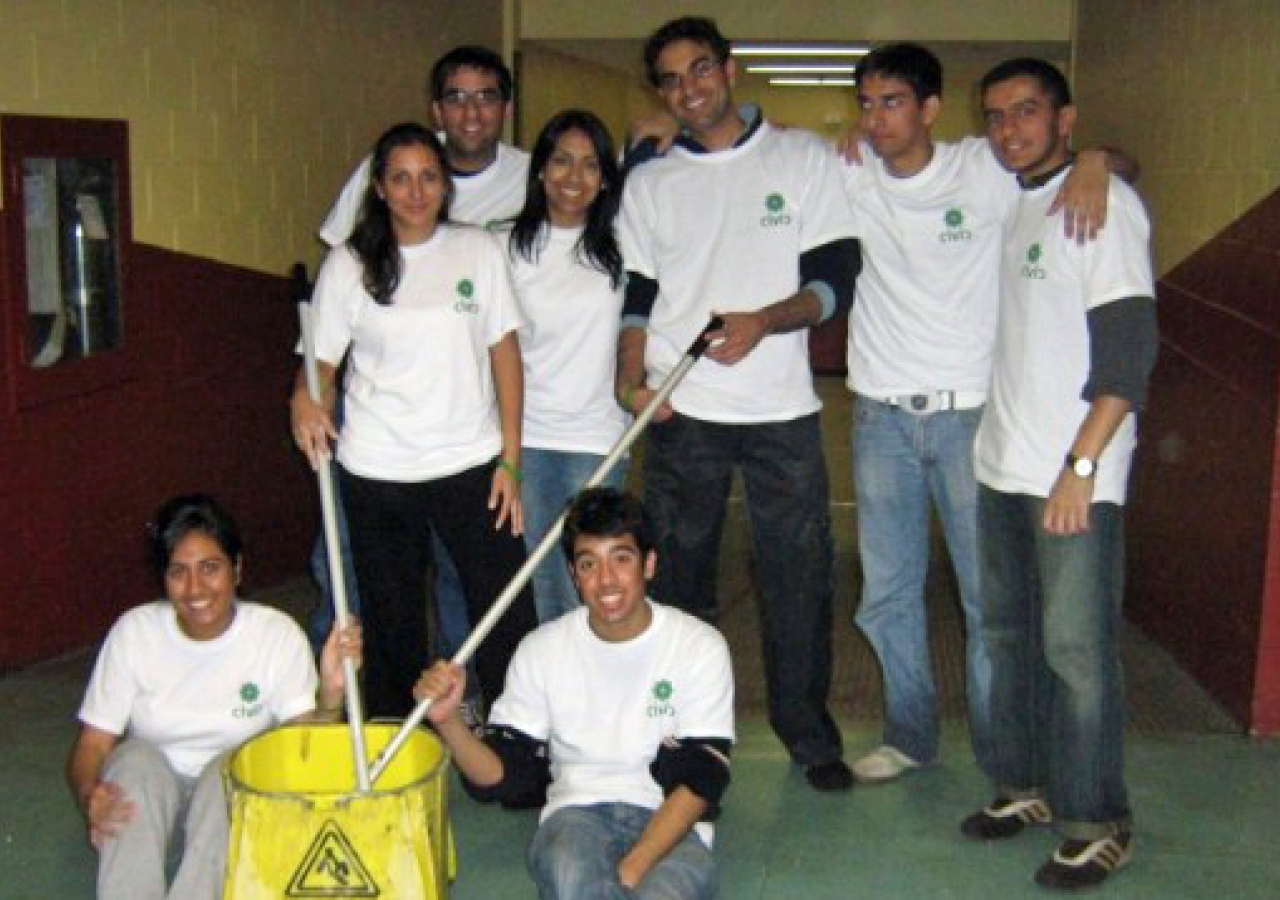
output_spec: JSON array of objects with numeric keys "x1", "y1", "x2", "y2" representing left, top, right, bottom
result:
[{"x1": 0, "y1": 379, "x2": 1280, "y2": 900}]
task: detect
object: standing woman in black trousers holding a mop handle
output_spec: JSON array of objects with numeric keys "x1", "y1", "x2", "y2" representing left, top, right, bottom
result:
[{"x1": 292, "y1": 123, "x2": 535, "y2": 717}]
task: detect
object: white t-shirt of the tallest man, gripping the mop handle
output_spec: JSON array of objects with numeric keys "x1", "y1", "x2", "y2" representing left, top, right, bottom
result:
[{"x1": 618, "y1": 122, "x2": 855, "y2": 422}]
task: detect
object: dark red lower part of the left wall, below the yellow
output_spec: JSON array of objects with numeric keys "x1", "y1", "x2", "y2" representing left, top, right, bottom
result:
[{"x1": 0, "y1": 243, "x2": 317, "y2": 671}]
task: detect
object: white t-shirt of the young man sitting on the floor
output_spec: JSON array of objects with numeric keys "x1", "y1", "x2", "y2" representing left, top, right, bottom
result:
[{"x1": 489, "y1": 603, "x2": 733, "y2": 844}]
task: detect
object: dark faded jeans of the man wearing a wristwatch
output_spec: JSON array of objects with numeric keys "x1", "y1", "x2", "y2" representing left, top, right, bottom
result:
[{"x1": 978, "y1": 485, "x2": 1130, "y2": 840}]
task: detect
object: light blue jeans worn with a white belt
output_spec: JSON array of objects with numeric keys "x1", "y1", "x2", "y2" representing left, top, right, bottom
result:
[{"x1": 852, "y1": 397, "x2": 991, "y2": 766}]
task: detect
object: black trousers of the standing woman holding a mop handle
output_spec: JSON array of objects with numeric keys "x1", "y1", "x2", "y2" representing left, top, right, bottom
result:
[{"x1": 339, "y1": 462, "x2": 535, "y2": 717}]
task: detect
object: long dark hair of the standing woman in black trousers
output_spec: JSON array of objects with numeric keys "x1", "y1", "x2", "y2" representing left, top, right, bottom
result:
[{"x1": 348, "y1": 122, "x2": 453, "y2": 306}]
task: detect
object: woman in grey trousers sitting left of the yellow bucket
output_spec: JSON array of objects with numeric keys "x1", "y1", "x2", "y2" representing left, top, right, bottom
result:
[{"x1": 67, "y1": 494, "x2": 360, "y2": 900}]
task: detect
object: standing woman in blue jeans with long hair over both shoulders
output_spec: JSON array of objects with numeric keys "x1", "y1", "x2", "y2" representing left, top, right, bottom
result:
[{"x1": 508, "y1": 109, "x2": 628, "y2": 622}]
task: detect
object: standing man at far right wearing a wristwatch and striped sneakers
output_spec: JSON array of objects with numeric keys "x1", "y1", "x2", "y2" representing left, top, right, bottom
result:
[{"x1": 961, "y1": 59, "x2": 1157, "y2": 890}]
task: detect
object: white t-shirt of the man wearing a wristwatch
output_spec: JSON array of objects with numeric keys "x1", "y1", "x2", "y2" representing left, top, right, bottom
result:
[{"x1": 974, "y1": 173, "x2": 1156, "y2": 503}]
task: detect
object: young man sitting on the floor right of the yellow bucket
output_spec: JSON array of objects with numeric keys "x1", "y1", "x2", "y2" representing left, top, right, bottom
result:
[{"x1": 415, "y1": 488, "x2": 733, "y2": 900}]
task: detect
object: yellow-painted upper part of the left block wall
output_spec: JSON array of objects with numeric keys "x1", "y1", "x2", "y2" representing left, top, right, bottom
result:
[{"x1": 0, "y1": 0, "x2": 502, "y2": 274}]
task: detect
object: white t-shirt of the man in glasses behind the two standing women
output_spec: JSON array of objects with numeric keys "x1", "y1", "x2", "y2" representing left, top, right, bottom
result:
[{"x1": 320, "y1": 143, "x2": 529, "y2": 240}]
